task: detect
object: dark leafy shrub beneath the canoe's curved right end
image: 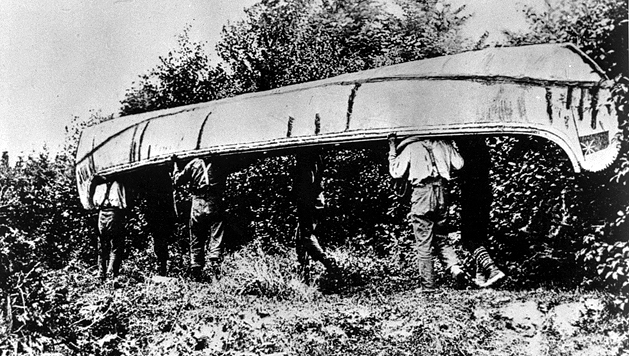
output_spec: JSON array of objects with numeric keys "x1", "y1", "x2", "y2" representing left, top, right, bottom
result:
[{"x1": 490, "y1": 138, "x2": 588, "y2": 286}]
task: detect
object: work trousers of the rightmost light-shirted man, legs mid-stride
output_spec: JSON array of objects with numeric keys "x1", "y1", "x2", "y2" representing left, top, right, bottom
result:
[{"x1": 409, "y1": 179, "x2": 459, "y2": 288}]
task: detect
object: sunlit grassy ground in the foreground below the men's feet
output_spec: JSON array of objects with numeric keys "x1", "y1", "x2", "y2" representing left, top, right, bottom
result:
[{"x1": 72, "y1": 277, "x2": 629, "y2": 356}]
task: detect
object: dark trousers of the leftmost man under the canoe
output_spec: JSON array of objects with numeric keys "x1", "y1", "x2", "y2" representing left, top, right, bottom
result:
[{"x1": 98, "y1": 208, "x2": 125, "y2": 279}]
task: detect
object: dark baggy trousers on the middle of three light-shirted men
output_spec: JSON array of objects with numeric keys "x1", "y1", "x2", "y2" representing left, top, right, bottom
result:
[{"x1": 190, "y1": 194, "x2": 225, "y2": 268}]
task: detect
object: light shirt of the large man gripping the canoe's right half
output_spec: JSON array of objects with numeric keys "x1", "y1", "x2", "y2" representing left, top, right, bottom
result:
[{"x1": 389, "y1": 140, "x2": 463, "y2": 185}]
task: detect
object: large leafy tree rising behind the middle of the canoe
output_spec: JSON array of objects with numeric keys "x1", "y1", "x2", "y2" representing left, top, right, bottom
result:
[{"x1": 216, "y1": 0, "x2": 465, "y2": 92}]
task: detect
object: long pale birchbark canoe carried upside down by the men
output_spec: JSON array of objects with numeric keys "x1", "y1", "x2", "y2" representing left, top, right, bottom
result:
[{"x1": 76, "y1": 44, "x2": 619, "y2": 209}]
